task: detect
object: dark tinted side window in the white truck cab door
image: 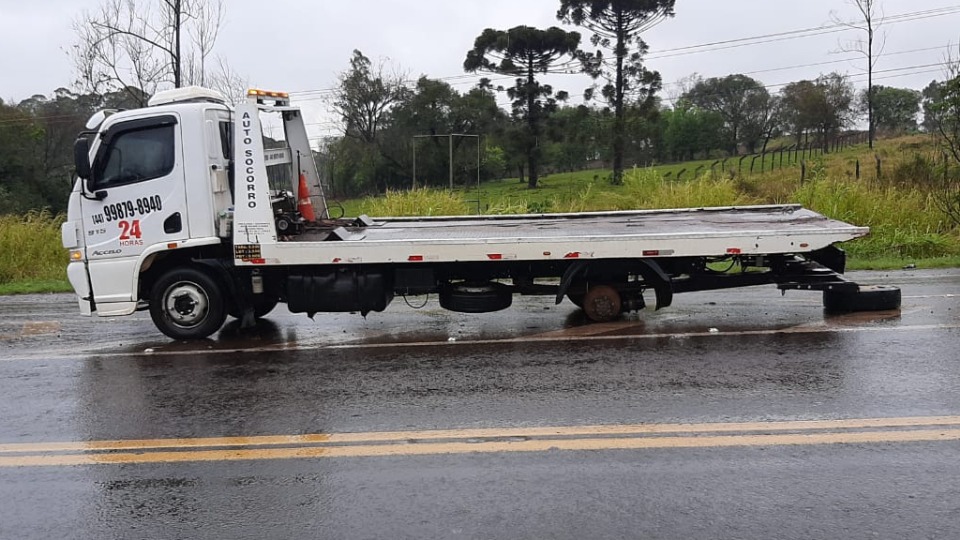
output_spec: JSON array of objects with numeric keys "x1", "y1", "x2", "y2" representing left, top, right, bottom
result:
[{"x1": 94, "y1": 125, "x2": 175, "y2": 189}]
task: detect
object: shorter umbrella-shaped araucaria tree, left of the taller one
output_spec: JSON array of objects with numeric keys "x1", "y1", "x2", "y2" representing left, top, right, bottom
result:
[{"x1": 463, "y1": 26, "x2": 580, "y2": 189}]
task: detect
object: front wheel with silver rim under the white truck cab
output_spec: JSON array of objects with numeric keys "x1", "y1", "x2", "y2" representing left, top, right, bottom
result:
[{"x1": 150, "y1": 268, "x2": 227, "y2": 339}]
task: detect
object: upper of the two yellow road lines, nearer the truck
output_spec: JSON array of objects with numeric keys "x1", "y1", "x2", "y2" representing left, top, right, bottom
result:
[{"x1": 0, "y1": 416, "x2": 960, "y2": 454}]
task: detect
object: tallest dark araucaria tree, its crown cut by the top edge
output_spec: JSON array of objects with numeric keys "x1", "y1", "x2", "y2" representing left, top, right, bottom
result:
[{"x1": 557, "y1": 0, "x2": 675, "y2": 184}]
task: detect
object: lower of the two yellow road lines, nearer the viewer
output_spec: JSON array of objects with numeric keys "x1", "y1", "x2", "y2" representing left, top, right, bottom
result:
[{"x1": 0, "y1": 429, "x2": 960, "y2": 468}]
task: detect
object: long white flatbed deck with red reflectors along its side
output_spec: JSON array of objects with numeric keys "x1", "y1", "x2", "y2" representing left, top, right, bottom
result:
[{"x1": 238, "y1": 205, "x2": 869, "y2": 264}]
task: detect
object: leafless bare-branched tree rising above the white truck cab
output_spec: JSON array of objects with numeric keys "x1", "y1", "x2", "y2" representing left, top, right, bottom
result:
[{"x1": 72, "y1": 0, "x2": 223, "y2": 104}]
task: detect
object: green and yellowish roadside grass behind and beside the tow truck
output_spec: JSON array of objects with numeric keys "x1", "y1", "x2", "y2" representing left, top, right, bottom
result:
[{"x1": 0, "y1": 136, "x2": 960, "y2": 294}]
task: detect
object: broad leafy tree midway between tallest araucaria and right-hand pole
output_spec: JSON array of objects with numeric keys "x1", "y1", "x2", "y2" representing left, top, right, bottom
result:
[{"x1": 684, "y1": 75, "x2": 772, "y2": 155}]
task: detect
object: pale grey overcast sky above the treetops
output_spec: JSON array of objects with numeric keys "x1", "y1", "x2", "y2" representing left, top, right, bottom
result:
[{"x1": 0, "y1": 0, "x2": 960, "y2": 136}]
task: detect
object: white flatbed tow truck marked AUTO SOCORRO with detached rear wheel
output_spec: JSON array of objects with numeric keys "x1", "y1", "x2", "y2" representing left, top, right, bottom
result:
[{"x1": 61, "y1": 87, "x2": 900, "y2": 340}]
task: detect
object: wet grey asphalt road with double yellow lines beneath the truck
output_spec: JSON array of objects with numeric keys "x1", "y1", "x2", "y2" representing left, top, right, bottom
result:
[{"x1": 0, "y1": 271, "x2": 960, "y2": 539}]
